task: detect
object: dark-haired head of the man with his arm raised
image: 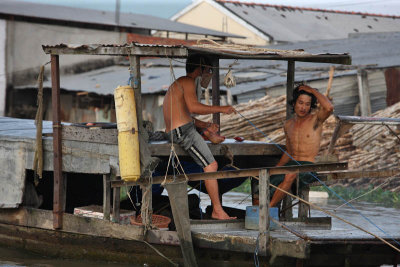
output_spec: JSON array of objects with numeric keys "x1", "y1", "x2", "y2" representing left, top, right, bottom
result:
[{"x1": 291, "y1": 84, "x2": 317, "y2": 117}]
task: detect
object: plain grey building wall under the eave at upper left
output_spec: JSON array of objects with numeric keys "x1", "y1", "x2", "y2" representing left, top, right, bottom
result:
[{"x1": 6, "y1": 21, "x2": 126, "y2": 84}]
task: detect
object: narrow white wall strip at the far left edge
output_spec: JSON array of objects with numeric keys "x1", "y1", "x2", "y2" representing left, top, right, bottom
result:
[{"x1": 0, "y1": 19, "x2": 7, "y2": 116}]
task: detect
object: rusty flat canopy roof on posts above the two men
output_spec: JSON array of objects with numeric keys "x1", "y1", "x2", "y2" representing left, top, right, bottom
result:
[{"x1": 43, "y1": 43, "x2": 351, "y2": 64}]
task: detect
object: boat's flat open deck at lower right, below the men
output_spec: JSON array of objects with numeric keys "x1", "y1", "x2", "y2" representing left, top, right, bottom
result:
[{"x1": 188, "y1": 199, "x2": 400, "y2": 266}]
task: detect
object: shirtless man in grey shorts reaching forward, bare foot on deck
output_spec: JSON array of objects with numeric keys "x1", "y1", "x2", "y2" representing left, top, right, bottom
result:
[{"x1": 163, "y1": 55, "x2": 235, "y2": 220}]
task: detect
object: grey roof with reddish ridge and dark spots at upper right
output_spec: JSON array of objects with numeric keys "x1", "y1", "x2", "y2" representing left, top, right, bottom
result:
[{"x1": 217, "y1": 1, "x2": 400, "y2": 42}]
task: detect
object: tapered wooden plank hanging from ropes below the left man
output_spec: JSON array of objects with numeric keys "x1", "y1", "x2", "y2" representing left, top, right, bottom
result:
[{"x1": 164, "y1": 182, "x2": 197, "y2": 267}]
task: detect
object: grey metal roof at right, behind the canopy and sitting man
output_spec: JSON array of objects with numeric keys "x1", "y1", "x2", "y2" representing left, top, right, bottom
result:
[{"x1": 220, "y1": 32, "x2": 400, "y2": 95}]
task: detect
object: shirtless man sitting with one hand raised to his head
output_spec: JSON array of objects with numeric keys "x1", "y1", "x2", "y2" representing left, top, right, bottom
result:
[{"x1": 270, "y1": 85, "x2": 333, "y2": 207}]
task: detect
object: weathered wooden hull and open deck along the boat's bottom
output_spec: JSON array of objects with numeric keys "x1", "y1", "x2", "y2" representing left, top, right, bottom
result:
[{"x1": 0, "y1": 205, "x2": 400, "y2": 266}]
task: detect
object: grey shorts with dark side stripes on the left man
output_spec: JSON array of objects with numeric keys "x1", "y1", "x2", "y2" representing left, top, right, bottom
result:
[{"x1": 167, "y1": 122, "x2": 215, "y2": 168}]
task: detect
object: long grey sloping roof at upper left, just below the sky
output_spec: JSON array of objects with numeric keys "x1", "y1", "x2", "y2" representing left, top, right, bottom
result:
[{"x1": 0, "y1": 0, "x2": 241, "y2": 38}]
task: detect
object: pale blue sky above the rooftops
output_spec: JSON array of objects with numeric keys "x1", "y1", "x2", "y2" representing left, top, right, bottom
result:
[{"x1": 18, "y1": 0, "x2": 400, "y2": 18}]
